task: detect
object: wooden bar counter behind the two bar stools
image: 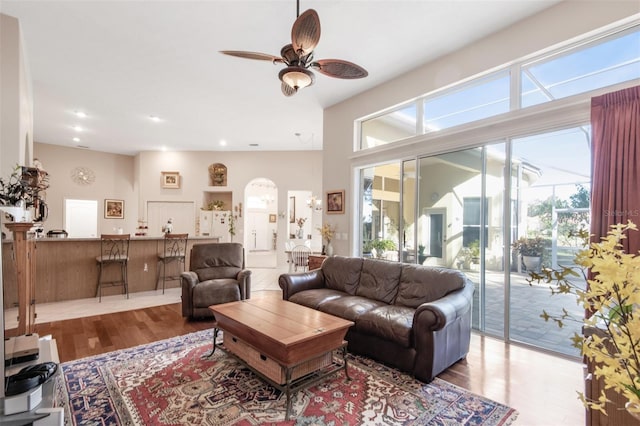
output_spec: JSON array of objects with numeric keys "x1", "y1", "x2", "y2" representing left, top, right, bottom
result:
[{"x1": 2, "y1": 236, "x2": 218, "y2": 308}]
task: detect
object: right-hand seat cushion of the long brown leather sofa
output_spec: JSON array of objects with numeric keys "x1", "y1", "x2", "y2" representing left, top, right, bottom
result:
[{"x1": 355, "y1": 305, "x2": 415, "y2": 348}]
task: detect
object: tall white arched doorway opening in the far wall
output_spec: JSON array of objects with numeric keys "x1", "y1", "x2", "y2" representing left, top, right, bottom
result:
[{"x1": 244, "y1": 178, "x2": 278, "y2": 268}]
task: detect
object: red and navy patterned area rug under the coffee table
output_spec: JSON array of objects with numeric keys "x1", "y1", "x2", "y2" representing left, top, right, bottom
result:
[{"x1": 56, "y1": 331, "x2": 517, "y2": 426}]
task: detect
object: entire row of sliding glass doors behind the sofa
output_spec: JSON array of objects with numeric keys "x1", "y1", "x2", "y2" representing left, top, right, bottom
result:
[{"x1": 361, "y1": 127, "x2": 590, "y2": 356}]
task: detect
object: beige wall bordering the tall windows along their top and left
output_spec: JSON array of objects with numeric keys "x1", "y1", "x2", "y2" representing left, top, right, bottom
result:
[{"x1": 323, "y1": 1, "x2": 640, "y2": 254}]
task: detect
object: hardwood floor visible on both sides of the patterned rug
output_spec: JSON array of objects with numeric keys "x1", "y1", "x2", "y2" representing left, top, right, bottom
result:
[{"x1": 36, "y1": 303, "x2": 585, "y2": 426}]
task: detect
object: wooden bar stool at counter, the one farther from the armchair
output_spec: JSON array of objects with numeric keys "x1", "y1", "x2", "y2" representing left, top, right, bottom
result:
[{"x1": 96, "y1": 234, "x2": 130, "y2": 302}]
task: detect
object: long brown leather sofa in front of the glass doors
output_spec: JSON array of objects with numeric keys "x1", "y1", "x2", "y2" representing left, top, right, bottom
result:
[{"x1": 278, "y1": 256, "x2": 474, "y2": 382}]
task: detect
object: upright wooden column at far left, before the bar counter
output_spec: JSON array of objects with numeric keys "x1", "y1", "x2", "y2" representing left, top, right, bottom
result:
[{"x1": 5, "y1": 222, "x2": 36, "y2": 336}]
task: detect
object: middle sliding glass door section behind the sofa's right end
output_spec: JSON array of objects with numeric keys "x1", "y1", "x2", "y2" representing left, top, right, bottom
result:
[{"x1": 417, "y1": 143, "x2": 505, "y2": 336}]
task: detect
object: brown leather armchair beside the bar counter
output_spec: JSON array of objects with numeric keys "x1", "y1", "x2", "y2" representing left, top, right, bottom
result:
[{"x1": 180, "y1": 243, "x2": 251, "y2": 318}]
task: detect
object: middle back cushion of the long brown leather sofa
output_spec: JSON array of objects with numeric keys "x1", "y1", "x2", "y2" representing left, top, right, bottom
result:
[{"x1": 356, "y1": 259, "x2": 402, "y2": 304}]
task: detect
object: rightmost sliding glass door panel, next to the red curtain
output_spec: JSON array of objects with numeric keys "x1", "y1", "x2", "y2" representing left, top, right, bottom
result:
[{"x1": 509, "y1": 127, "x2": 591, "y2": 356}]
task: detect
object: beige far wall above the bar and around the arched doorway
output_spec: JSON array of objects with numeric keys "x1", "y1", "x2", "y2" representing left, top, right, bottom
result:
[{"x1": 35, "y1": 143, "x2": 322, "y2": 260}]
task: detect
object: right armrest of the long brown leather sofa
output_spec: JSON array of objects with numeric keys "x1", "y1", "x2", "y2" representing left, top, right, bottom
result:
[{"x1": 413, "y1": 279, "x2": 474, "y2": 334}]
